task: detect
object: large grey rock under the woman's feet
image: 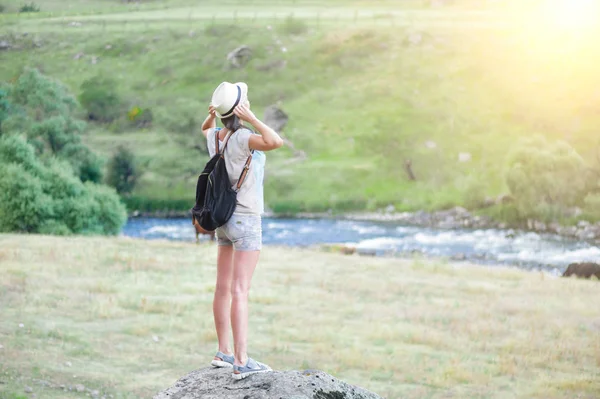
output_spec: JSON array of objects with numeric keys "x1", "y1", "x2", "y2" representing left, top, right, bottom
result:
[{"x1": 154, "y1": 368, "x2": 381, "y2": 399}]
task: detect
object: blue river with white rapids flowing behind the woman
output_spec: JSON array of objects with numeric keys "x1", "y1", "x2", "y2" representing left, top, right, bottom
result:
[{"x1": 123, "y1": 218, "x2": 600, "y2": 275}]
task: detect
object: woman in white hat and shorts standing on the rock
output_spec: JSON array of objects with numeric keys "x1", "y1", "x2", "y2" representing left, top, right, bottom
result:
[{"x1": 202, "y1": 82, "x2": 283, "y2": 380}]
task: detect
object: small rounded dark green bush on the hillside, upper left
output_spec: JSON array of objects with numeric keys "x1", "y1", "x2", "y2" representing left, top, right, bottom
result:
[{"x1": 79, "y1": 76, "x2": 122, "y2": 123}]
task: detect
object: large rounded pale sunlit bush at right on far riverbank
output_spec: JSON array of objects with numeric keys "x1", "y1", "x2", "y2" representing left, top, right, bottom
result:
[{"x1": 506, "y1": 137, "x2": 587, "y2": 220}]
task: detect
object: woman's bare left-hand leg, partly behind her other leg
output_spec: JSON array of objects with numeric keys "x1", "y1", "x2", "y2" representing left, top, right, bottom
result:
[{"x1": 213, "y1": 245, "x2": 233, "y2": 360}]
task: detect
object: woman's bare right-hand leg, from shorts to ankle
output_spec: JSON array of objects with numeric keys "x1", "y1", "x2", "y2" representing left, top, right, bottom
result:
[{"x1": 231, "y1": 251, "x2": 260, "y2": 366}]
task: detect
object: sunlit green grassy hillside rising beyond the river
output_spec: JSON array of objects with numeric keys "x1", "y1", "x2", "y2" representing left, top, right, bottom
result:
[{"x1": 0, "y1": 0, "x2": 600, "y2": 216}]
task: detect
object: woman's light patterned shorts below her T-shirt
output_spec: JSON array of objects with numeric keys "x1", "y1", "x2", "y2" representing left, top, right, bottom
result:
[{"x1": 217, "y1": 213, "x2": 262, "y2": 251}]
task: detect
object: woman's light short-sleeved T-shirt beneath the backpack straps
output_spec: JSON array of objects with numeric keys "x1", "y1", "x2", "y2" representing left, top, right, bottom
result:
[{"x1": 206, "y1": 128, "x2": 266, "y2": 215}]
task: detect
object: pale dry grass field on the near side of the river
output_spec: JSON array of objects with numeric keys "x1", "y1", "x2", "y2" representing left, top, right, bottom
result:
[{"x1": 0, "y1": 235, "x2": 600, "y2": 399}]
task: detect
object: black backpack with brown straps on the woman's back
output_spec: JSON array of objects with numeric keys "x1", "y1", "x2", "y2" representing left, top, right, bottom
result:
[{"x1": 191, "y1": 131, "x2": 252, "y2": 232}]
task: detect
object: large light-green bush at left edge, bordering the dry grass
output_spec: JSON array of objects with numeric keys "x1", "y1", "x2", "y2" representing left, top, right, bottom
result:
[{"x1": 0, "y1": 135, "x2": 127, "y2": 235}]
